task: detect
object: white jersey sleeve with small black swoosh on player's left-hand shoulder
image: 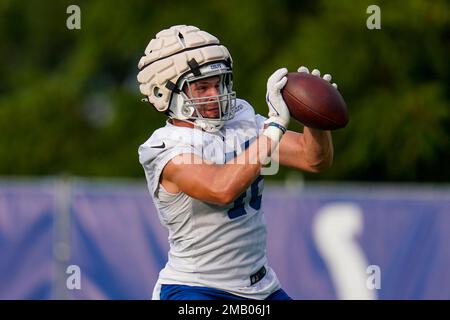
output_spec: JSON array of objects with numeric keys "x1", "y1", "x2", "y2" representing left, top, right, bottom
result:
[{"x1": 138, "y1": 129, "x2": 202, "y2": 198}]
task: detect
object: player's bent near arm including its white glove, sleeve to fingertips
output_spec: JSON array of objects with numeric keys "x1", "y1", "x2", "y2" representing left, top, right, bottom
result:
[{"x1": 161, "y1": 69, "x2": 290, "y2": 205}]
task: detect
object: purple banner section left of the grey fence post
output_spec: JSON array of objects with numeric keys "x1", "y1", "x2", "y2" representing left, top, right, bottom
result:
[{"x1": 0, "y1": 183, "x2": 55, "y2": 299}]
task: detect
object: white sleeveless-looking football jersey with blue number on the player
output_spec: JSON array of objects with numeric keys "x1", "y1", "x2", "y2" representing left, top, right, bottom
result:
[{"x1": 139, "y1": 99, "x2": 280, "y2": 299}]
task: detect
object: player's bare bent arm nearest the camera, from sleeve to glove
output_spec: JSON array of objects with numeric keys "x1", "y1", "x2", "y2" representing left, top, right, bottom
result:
[{"x1": 160, "y1": 135, "x2": 274, "y2": 205}]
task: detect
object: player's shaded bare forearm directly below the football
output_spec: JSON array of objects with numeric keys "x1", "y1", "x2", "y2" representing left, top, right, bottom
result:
[{"x1": 303, "y1": 127, "x2": 333, "y2": 172}]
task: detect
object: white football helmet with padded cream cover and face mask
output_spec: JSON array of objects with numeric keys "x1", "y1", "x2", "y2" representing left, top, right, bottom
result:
[{"x1": 137, "y1": 25, "x2": 236, "y2": 132}]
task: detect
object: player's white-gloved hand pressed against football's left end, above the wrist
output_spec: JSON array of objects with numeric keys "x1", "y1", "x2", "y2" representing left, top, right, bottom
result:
[{"x1": 266, "y1": 68, "x2": 290, "y2": 128}]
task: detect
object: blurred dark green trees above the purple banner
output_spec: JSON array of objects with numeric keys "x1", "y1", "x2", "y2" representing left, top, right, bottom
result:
[{"x1": 0, "y1": 0, "x2": 450, "y2": 182}]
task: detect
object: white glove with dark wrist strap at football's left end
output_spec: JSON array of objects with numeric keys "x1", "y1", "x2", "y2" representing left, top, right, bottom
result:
[{"x1": 263, "y1": 68, "x2": 291, "y2": 143}]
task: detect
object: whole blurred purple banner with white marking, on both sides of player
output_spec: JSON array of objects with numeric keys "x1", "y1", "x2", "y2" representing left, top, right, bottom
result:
[{"x1": 0, "y1": 181, "x2": 450, "y2": 299}]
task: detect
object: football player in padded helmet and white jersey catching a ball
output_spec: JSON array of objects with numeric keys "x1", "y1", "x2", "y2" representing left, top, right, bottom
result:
[{"x1": 138, "y1": 25, "x2": 333, "y2": 300}]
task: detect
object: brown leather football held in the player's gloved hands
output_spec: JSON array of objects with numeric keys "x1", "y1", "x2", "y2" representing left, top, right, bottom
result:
[{"x1": 281, "y1": 72, "x2": 348, "y2": 130}]
